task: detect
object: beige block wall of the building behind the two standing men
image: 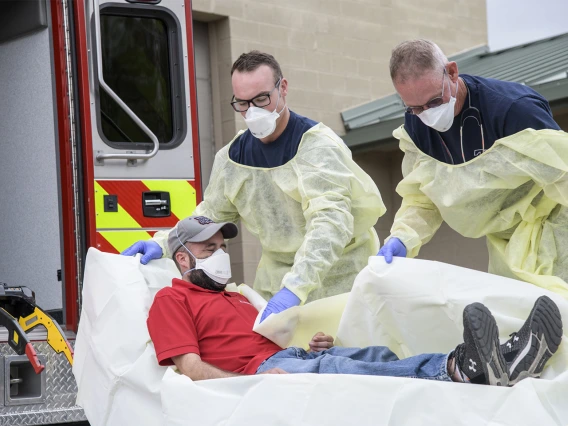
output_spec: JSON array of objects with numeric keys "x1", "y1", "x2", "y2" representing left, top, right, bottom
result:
[{"x1": 192, "y1": 0, "x2": 487, "y2": 283}]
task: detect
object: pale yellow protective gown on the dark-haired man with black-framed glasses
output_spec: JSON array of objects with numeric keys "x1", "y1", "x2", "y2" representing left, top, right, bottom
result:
[{"x1": 154, "y1": 123, "x2": 386, "y2": 302}]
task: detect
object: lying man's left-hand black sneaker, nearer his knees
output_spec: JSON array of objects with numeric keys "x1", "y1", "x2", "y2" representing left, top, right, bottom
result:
[{"x1": 454, "y1": 303, "x2": 509, "y2": 386}]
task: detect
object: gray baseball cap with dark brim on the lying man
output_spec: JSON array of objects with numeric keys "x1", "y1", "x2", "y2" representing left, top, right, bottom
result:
[{"x1": 168, "y1": 216, "x2": 239, "y2": 255}]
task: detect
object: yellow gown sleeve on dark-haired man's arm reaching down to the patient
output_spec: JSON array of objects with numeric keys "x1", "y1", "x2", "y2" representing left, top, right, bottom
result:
[{"x1": 282, "y1": 134, "x2": 385, "y2": 302}]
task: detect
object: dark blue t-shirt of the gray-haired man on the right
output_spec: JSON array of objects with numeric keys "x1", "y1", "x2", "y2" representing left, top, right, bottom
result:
[{"x1": 404, "y1": 74, "x2": 560, "y2": 164}]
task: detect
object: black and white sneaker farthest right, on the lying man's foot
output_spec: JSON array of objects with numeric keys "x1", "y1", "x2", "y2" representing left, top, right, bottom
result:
[{"x1": 501, "y1": 296, "x2": 562, "y2": 386}]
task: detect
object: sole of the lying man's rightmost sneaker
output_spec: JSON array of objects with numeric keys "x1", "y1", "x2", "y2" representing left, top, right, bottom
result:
[{"x1": 509, "y1": 296, "x2": 562, "y2": 386}]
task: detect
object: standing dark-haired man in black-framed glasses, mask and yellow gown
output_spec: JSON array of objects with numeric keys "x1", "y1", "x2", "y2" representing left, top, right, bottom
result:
[{"x1": 123, "y1": 51, "x2": 385, "y2": 319}]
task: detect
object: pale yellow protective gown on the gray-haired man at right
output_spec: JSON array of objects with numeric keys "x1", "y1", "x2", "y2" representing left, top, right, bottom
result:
[{"x1": 391, "y1": 126, "x2": 568, "y2": 297}]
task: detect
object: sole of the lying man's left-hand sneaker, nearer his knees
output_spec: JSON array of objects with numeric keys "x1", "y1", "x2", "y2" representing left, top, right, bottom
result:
[{"x1": 463, "y1": 303, "x2": 509, "y2": 386}]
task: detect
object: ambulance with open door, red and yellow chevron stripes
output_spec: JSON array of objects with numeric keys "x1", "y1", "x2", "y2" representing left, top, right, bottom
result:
[{"x1": 0, "y1": 0, "x2": 202, "y2": 426}]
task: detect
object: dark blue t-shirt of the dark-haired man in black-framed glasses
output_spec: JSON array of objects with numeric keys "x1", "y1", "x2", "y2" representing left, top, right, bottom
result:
[{"x1": 229, "y1": 111, "x2": 318, "y2": 168}]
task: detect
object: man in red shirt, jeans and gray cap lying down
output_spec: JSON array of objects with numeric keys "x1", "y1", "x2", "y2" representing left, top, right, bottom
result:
[{"x1": 147, "y1": 217, "x2": 562, "y2": 386}]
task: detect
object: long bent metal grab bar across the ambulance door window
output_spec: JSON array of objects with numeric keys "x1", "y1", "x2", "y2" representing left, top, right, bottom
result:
[{"x1": 93, "y1": 0, "x2": 160, "y2": 163}]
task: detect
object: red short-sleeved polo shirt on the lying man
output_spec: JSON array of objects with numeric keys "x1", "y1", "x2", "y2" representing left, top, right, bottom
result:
[{"x1": 147, "y1": 278, "x2": 282, "y2": 374}]
